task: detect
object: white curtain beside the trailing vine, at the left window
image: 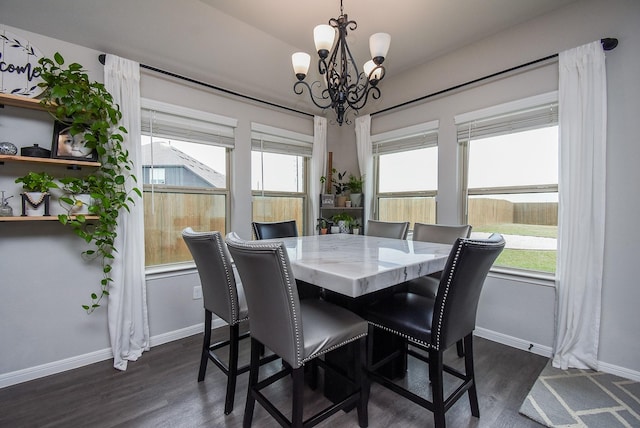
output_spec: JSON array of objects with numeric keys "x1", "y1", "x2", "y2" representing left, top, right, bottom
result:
[{"x1": 104, "y1": 55, "x2": 149, "y2": 370}]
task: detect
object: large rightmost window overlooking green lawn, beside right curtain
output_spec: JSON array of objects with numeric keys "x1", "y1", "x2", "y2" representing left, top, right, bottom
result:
[{"x1": 456, "y1": 93, "x2": 558, "y2": 273}]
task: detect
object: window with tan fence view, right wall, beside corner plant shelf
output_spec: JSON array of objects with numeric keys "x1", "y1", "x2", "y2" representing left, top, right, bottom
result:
[{"x1": 371, "y1": 121, "x2": 438, "y2": 229}]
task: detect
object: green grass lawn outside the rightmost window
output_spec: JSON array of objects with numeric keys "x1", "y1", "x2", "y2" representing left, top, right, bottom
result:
[{"x1": 473, "y1": 223, "x2": 558, "y2": 273}]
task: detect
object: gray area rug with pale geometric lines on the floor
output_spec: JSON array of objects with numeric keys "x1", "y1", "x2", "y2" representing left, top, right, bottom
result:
[{"x1": 520, "y1": 361, "x2": 640, "y2": 428}]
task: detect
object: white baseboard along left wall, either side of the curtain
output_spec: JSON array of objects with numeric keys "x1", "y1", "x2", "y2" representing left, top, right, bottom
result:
[{"x1": 0, "y1": 318, "x2": 226, "y2": 388}]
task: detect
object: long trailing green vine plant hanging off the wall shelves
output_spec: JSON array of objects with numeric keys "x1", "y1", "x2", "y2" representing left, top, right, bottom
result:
[{"x1": 39, "y1": 52, "x2": 142, "y2": 313}]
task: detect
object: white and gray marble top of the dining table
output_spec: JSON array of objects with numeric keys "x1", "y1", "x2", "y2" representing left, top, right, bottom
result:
[{"x1": 278, "y1": 234, "x2": 451, "y2": 297}]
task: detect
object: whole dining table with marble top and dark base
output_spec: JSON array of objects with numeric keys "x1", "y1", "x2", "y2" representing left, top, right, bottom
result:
[{"x1": 277, "y1": 233, "x2": 452, "y2": 402}]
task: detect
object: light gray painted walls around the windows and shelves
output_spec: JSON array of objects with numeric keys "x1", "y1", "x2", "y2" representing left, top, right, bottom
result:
[{"x1": 0, "y1": 0, "x2": 640, "y2": 386}]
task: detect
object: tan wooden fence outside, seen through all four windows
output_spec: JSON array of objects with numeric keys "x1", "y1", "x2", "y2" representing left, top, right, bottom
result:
[{"x1": 144, "y1": 191, "x2": 558, "y2": 266}]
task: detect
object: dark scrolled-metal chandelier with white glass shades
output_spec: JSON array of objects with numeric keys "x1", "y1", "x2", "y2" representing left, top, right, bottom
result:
[{"x1": 291, "y1": 0, "x2": 391, "y2": 126}]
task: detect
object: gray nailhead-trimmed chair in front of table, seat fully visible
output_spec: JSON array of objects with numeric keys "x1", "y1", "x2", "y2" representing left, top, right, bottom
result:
[{"x1": 227, "y1": 233, "x2": 369, "y2": 427}]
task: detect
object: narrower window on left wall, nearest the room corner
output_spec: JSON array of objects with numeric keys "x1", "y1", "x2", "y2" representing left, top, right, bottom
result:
[{"x1": 251, "y1": 123, "x2": 313, "y2": 235}]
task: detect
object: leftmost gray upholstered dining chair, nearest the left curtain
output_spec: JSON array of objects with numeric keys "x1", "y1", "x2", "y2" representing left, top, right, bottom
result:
[{"x1": 182, "y1": 227, "x2": 277, "y2": 415}]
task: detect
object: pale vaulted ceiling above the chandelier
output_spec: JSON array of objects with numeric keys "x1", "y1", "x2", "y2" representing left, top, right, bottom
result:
[{"x1": 0, "y1": 0, "x2": 579, "y2": 113}]
